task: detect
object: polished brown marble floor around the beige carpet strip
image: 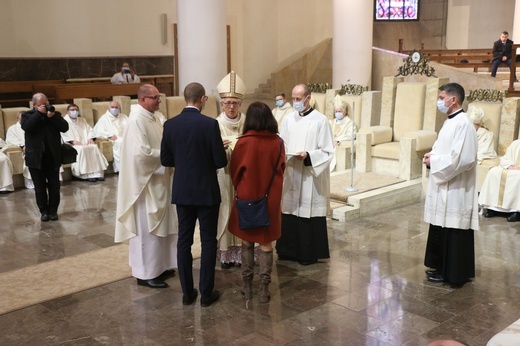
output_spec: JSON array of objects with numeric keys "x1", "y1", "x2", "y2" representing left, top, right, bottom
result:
[{"x1": 0, "y1": 175, "x2": 520, "y2": 345}]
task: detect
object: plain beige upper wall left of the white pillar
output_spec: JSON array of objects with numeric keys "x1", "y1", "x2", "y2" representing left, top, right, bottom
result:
[{"x1": 0, "y1": 0, "x2": 177, "y2": 58}]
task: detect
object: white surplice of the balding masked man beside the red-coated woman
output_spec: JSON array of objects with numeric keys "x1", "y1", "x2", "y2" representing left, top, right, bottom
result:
[{"x1": 280, "y1": 110, "x2": 334, "y2": 218}]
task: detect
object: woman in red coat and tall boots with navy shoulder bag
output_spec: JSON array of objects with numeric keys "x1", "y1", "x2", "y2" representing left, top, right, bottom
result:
[{"x1": 228, "y1": 102, "x2": 285, "y2": 303}]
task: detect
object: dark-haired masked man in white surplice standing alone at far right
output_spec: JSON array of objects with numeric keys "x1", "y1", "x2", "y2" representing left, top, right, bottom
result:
[{"x1": 423, "y1": 83, "x2": 479, "y2": 285}]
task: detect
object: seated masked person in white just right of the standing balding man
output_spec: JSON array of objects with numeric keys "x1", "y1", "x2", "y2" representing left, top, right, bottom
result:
[{"x1": 330, "y1": 95, "x2": 357, "y2": 172}]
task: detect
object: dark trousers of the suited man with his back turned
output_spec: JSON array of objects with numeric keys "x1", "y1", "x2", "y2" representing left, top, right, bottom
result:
[{"x1": 177, "y1": 204, "x2": 220, "y2": 297}]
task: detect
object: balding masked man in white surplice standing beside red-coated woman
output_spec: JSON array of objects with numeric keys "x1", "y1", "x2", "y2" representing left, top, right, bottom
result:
[{"x1": 276, "y1": 84, "x2": 334, "y2": 265}]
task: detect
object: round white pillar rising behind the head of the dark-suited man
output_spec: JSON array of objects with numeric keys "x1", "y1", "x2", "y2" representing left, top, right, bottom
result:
[{"x1": 176, "y1": 0, "x2": 227, "y2": 95}]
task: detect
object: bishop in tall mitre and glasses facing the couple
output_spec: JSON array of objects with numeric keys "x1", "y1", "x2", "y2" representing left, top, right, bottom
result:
[{"x1": 217, "y1": 71, "x2": 246, "y2": 269}]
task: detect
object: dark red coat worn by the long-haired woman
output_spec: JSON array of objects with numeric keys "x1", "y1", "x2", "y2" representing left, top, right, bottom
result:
[{"x1": 228, "y1": 131, "x2": 285, "y2": 244}]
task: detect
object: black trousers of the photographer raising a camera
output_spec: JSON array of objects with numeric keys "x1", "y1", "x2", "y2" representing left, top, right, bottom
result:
[{"x1": 29, "y1": 153, "x2": 60, "y2": 215}]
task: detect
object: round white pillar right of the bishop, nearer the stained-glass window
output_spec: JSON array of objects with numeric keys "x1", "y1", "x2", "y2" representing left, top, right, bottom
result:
[{"x1": 332, "y1": 0, "x2": 374, "y2": 88}]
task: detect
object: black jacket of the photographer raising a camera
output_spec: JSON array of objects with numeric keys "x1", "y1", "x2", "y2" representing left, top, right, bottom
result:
[{"x1": 21, "y1": 109, "x2": 69, "y2": 169}]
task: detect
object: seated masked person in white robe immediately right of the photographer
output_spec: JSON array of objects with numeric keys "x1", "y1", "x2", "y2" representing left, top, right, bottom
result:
[{"x1": 61, "y1": 103, "x2": 108, "y2": 182}]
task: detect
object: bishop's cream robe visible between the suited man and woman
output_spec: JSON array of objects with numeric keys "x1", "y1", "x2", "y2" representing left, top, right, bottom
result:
[{"x1": 217, "y1": 112, "x2": 246, "y2": 251}]
